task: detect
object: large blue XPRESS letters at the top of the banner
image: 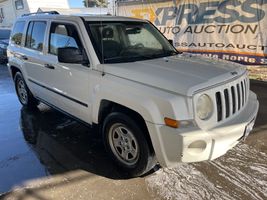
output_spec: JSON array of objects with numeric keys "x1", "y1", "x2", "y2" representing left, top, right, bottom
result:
[{"x1": 154, "y1": 0, "x2": 267, "y2": 26}]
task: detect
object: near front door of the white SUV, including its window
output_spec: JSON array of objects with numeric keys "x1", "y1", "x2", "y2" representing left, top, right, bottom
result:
[{"x1": 40, "y1": 22, "x2": 91, "y2": 123}]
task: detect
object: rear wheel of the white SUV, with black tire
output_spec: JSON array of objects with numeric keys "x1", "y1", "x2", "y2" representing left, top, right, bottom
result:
[{"x1": 14, "y1": 72, "x2": 39, "y2": 108}]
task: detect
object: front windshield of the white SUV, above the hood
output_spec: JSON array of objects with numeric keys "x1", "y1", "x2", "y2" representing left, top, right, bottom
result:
[{"x1": 87, "y1": 21, "x2": 178, "y2": 63}]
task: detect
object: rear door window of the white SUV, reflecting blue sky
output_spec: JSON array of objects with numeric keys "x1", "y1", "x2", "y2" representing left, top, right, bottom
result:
[{"x1": 25, "y1": 21, "x2": 46, "y2": 51}]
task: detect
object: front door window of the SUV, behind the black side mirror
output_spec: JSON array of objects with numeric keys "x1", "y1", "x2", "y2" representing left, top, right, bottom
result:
[{"x1": 49, "y1": 23, "x2": 82, "y2": 55}]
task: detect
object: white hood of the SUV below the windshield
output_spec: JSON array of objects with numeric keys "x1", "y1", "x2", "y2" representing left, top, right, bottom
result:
[{"x1": 104, "y1": 54, "x2": 246, "y2": 96}]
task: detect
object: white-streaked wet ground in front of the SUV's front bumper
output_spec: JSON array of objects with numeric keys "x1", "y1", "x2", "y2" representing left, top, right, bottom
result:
[{"x1": 146, "y1": 144, "x2": 267, "y2": 200}]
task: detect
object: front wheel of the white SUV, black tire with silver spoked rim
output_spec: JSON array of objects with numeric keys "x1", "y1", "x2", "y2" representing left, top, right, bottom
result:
[{"x1": 102, "y1": 112, "x2": 156, "y2": 177}]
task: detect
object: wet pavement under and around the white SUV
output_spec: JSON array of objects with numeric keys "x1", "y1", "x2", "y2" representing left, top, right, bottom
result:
[{"x1": 0, "y1": 65, "x2": 267, "y2": 200}]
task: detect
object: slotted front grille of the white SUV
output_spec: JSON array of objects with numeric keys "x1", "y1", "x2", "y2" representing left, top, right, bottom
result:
[{"x1": 215, "y1": 78, "x2": 249, "y2": 122}]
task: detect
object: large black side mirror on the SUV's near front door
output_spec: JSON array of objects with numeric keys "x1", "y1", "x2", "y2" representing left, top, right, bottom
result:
[{"x1": 57, "y1": 47, "x2": 89, "y2": 64}]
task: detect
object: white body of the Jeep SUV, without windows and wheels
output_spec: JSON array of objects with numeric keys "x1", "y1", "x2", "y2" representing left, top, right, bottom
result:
[{"x1": 8, "y1": 12, "x2": 258, "y2": 167}]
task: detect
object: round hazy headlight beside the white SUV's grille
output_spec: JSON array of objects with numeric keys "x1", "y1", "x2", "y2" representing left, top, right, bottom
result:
[{"x1": 197, "y1": 94, "x2": 213, "y2": 120}]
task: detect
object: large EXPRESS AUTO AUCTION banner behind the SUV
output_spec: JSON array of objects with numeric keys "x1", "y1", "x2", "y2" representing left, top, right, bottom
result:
[{"x1": 118, "y1": 0, "x2": 267, "y2": 65}]
